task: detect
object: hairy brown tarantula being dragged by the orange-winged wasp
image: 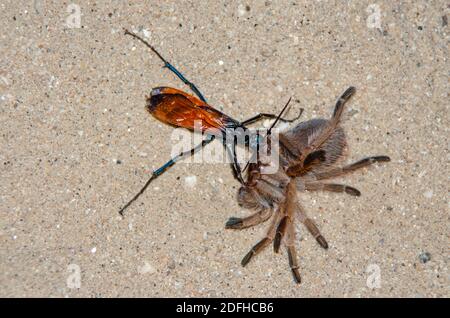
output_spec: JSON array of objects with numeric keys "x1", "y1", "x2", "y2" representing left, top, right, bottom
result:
[{"x1": 226, "y1": 87, "x2": 390, "y2": 283}]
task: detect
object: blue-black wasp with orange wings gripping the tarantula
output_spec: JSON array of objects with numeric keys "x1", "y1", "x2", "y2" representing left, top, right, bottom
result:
[{"x1": 119, "y1": 29, "x2": 303, "y2": 215}]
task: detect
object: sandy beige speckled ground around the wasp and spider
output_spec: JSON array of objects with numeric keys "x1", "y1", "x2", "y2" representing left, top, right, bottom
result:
[{"x1": 0, "y1": 0, "x2": 449, "y2": 297}]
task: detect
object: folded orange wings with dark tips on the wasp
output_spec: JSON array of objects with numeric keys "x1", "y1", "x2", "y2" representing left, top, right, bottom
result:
[{"x1": 147, "y1": 87, "x2": 239, "y2": 133}]
